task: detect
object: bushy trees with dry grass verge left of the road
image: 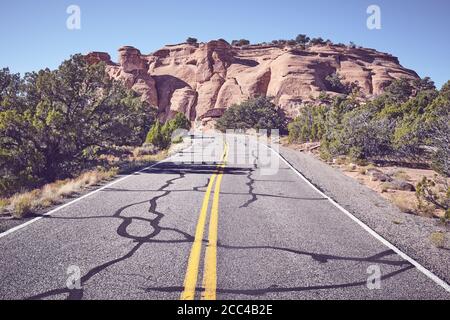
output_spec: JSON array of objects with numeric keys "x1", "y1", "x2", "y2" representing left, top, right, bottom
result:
[{"x1": 0, "y1": 55, "x2": 189, "y2": 217}]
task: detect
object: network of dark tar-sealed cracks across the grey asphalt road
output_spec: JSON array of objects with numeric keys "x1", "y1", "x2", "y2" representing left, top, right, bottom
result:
[{"x1": 28, "y1": 159, "x2": 413, "y2": 300}]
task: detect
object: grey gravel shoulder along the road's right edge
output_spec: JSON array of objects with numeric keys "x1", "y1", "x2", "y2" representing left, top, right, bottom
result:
[{"x1": 279, "y1": 146, "x2": 450, "y2": 283}]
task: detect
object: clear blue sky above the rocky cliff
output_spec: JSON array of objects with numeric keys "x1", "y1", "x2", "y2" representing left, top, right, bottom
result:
[{"x1": 0, "y1": 0, "x2": 450, "y2": 87}]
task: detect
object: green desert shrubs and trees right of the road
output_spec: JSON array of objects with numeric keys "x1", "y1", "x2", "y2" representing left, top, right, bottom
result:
[{"x1": 289, "y1": 75, "x2": 450, "y2": 220}]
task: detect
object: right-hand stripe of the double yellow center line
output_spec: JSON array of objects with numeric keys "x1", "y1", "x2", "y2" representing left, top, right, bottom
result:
[{"x1": 201, "y1": 146, "x2": 228, "y2": 300}]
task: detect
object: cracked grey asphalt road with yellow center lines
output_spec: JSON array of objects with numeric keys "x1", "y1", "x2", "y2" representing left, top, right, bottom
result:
[{"x1": 0, "y1": 137, "x2": 450, "y2": 299}]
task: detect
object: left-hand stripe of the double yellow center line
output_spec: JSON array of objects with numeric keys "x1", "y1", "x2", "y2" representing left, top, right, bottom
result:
[{"x1": 180, "y1": 144, "x2": 225, "y2": 300}]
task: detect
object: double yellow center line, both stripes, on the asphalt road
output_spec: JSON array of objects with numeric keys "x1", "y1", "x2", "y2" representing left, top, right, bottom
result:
[{"x1": 181, "y1": 144, "x2": 228, "y2": 300}]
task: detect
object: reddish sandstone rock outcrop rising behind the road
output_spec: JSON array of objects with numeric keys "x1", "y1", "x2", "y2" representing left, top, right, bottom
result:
[{"x1": 87, "y1": 40, "x2": 418, "y2": 121}]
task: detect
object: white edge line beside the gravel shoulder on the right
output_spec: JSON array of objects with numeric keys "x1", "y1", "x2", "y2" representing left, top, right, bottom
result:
[{"x1": 263, "y1": 144, "x2": 450, "y2": 292}]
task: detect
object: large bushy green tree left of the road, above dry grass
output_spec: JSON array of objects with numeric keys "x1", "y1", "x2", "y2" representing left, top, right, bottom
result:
[{"x1": 0, "y1": 55, "x2": 154, "y2": 195}]
